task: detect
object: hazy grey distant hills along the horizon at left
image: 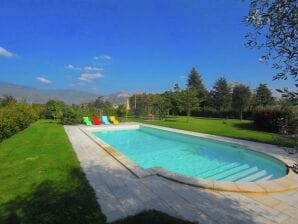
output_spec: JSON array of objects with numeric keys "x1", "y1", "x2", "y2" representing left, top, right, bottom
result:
[{"x1": 0, "y1": 82, "x2": 129, "y2": 104}]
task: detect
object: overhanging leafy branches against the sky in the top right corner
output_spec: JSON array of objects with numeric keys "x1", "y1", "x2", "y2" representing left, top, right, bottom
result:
[{"x1": 245, "y1": 0, "x2": 298, "y2": 100}]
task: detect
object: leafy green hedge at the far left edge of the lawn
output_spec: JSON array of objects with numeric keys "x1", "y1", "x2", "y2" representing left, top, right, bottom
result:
[{"x1": 0, "y1": 103, "x2": 40, "y2": 141}]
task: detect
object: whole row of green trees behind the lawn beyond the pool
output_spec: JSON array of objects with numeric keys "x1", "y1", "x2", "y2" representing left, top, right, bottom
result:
[{"x1": 130, "y1": 68, "x2": 284, "y2": 119}]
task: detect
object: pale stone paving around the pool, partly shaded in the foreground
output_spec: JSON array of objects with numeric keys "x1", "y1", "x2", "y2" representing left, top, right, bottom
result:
[{"x1": 65, "y1": 126, "x2": 298, "y2": 224}]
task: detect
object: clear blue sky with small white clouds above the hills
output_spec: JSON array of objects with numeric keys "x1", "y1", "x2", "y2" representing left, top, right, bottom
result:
[{"x1": 0, "y1": 0, "x2": 287, "y2": 94}]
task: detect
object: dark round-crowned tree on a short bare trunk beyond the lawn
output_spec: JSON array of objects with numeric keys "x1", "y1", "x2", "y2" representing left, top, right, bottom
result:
[{"x1": 232, "y1": 84, "x2": 251, "y2": 120}]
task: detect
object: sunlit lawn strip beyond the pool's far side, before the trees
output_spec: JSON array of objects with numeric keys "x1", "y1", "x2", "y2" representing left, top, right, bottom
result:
[{"x1": 128, "y1": 116, "x2": 279, "y2": 144}]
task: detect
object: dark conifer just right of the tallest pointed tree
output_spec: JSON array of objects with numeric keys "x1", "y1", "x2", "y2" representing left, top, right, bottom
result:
[{"x1": 211, "y1": 77, "x2": 232, "y2": 111}]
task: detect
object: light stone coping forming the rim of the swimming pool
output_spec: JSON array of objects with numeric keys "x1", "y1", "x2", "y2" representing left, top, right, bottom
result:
[{"x1": 80, "y1": 123, "x2": 298, "y2": 193}]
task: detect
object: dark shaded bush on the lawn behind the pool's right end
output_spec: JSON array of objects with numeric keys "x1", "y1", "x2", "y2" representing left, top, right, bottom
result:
[{"x1": 253, "y1": 108, "x2": 294, "y2": 132}]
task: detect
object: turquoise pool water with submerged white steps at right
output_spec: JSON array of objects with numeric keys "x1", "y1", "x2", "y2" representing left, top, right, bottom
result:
[{"x1": 94, "y1": 126, "x2": 286, "y2": 182}]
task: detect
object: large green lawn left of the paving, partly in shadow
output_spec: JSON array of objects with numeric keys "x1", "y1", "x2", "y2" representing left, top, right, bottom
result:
[{"x1": 0, "y1": 120, "x2": 191, "y2": 224}]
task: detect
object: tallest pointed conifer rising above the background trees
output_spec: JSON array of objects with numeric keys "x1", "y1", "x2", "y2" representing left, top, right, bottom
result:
[{"x1": 187, "y1": 68, "x2": 208, "y2": 107}]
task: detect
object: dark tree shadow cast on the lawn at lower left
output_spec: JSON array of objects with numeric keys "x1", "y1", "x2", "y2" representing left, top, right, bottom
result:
[{"x1": 0, "y1": 169, "x2": 106, "y2": 224}]
